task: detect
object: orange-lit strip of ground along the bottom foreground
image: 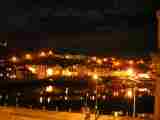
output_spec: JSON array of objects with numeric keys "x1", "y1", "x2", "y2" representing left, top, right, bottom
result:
[{"x1": 0, "y1": 107, "x2": 143, "y2": 120}]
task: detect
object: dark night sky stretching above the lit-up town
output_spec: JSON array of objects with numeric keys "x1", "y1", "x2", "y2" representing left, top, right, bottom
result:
[{"x1": 0, "y1": 0, "x2": 155, "y2": 52}]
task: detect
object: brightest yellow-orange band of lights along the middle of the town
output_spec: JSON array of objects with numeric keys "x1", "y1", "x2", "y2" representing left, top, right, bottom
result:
[{"x1": 27, "y1": 63, "x2": 152, "y2": 80}]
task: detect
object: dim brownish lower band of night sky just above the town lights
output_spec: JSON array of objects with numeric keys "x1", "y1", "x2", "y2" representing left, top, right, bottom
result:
[{"x1": 1, "y1": 30, "x2": 148, "y2": 52}]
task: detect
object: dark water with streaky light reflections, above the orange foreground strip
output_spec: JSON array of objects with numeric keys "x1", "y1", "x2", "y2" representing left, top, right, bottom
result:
[{"x1": 0, "y1": 85, "x2": 154, "y2": 114}]
